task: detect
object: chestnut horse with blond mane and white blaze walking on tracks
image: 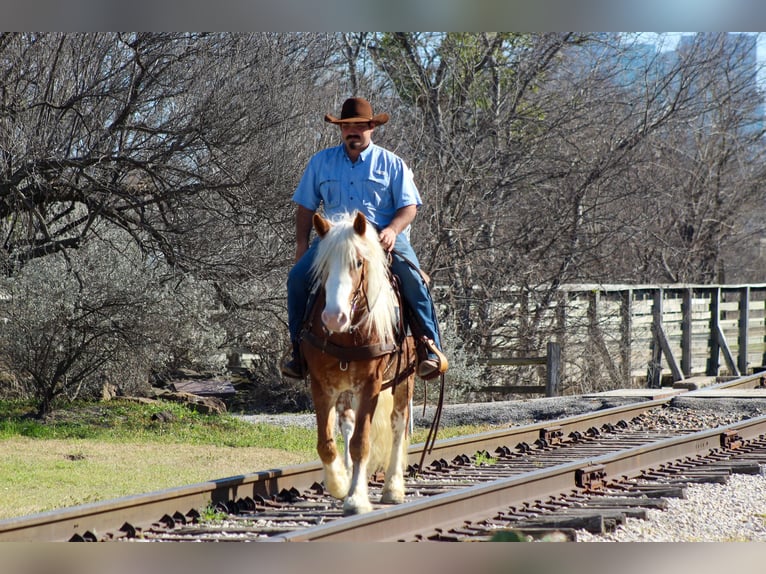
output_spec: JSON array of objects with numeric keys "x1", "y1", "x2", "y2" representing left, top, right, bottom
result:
[{"x1": 301, "y1": 212, "x2": 417, "y2": 515}]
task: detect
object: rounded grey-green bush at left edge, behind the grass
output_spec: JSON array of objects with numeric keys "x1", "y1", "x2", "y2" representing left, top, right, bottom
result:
[{"x1": 0, "y1": 231, "x2": 223, "y2": 416}]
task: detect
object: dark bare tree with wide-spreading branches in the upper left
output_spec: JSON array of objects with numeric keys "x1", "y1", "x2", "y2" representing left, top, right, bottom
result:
[{"x1": 0, "y1": 34, "x2": 336, "y2": 269}]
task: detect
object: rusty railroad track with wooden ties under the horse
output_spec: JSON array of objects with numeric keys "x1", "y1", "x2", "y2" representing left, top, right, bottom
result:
[{"x1": 0, "y1": 376, "x2": 766, "y2": 542}]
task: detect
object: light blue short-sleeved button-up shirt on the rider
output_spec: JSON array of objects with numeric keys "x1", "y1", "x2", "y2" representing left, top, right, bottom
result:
[{"x1": 293, "y1": 143, "x2": 422, "y2": 237}]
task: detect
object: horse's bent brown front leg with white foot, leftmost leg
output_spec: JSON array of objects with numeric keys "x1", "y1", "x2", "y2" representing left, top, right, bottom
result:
[{"x1": 311, "y1": 379, "x2": 348, "y2": 498}]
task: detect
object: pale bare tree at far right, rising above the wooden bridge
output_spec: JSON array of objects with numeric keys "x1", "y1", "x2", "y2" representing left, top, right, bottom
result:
[{"x1": 628, "y1": 34, "x2": 766, "y2": 283}]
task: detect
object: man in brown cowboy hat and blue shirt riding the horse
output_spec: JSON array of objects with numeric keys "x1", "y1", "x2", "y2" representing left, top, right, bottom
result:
[{"x1": 281, "y1": 98, "x2": 447, "y2": 379}]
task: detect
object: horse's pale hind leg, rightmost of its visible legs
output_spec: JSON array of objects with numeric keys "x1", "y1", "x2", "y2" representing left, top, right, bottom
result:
[{"x1": 380, "y1": 378, "x2": 414, "y2": 504}]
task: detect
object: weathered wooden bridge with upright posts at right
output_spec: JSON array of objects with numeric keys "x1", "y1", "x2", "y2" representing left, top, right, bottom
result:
[{"x1": 562, "y1": 285, "x2": 766, "y2": 387}]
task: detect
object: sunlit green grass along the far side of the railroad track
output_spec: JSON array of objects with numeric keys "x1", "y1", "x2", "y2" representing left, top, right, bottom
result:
[{"x1": 0, "y1": 400, "x2": 486, "y2": 520}]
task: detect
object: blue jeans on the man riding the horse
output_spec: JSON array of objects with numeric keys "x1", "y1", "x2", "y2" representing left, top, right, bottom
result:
[{"x1": 287, "y1": 234, "x2": 442, "y2": 350}]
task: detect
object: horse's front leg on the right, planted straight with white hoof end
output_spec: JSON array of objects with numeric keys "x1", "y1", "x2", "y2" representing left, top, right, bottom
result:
[{"x1": 343, "y1": 383, "x2": 378, "y2": 515}]
